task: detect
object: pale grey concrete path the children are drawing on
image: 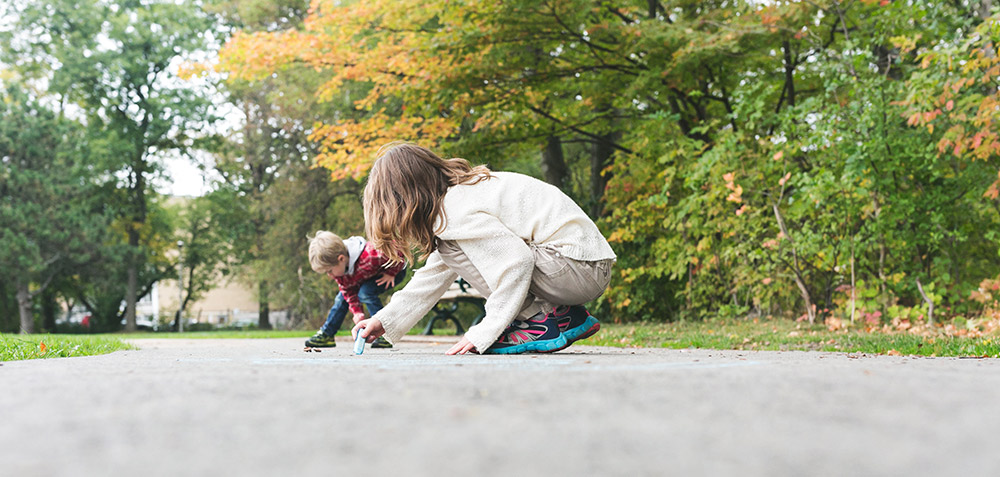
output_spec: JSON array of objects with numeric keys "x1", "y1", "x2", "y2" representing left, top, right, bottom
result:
[{"x1": 0, "y1": 337, "x2": 1000, "y2": 476}]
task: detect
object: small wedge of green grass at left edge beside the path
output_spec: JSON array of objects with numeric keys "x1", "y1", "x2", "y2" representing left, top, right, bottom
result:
[{"x1": 0, "y1": 333, "x2": 135, "y2": 361}]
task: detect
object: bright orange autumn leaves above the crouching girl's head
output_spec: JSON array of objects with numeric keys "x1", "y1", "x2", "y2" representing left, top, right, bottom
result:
[{"x1": 218, "y1": 0, "x2": 508, "y2": 179}]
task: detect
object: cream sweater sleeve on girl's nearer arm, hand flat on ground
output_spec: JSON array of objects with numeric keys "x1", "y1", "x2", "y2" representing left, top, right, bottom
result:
[{"x1": 457, "y1": 214, "x2": 535, "y2": 352}]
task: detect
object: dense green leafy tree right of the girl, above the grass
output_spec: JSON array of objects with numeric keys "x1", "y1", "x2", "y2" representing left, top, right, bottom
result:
[{"x1": 609, "y1": 2, "x2": 996, "y2": 321}]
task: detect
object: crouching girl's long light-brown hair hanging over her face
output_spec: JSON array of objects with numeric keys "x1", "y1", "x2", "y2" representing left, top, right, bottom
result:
[{"x1": 364, "y1": 142, "x2": 492, "y2": 263}]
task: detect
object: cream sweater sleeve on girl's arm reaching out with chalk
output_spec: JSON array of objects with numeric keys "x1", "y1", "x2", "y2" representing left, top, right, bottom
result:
[{"x1": 376, "y1": 252, "x2": 458, "y2": 343}]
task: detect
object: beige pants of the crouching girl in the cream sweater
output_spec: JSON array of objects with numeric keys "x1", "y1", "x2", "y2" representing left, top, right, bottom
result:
[{"x1": 438, "y1": 240, "x2": 615, "y2": 320}]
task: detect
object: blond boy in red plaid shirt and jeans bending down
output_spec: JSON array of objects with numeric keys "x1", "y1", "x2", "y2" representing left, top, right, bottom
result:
[{"x1": 306, "y1": 230, "x2": 406, "y2": 348}]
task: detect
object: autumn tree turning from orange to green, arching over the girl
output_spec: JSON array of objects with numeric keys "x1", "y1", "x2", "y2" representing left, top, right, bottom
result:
[{"x1": 222, "y1": 1, "x2": 641, "y2": 205}]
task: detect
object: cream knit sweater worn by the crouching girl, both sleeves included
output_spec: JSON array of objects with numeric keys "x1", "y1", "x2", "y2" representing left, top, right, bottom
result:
[{"x1": 377, "y1": 172, "x2": 615, "y2": 351}]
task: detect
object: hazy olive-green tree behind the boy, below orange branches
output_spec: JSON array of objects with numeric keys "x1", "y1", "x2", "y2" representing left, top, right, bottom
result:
[{"x1": 206, "y1": 0, "x2": 372, "y2": 328}]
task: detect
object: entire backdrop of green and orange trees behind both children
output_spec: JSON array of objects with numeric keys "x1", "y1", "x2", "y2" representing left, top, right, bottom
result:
[{"x1": 0, "y1": 0, "x2": 1000, "y2": 332}]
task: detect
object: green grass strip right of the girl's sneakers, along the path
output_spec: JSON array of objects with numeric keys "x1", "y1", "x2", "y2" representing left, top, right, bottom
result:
[{"x1": 581, "y1": 320, "x2": 1000, "y2": 357}]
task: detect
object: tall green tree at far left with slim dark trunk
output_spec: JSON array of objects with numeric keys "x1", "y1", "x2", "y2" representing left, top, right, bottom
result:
[{"x1": 7, "y1": 0, "x2": 212, "y2": 331}]
